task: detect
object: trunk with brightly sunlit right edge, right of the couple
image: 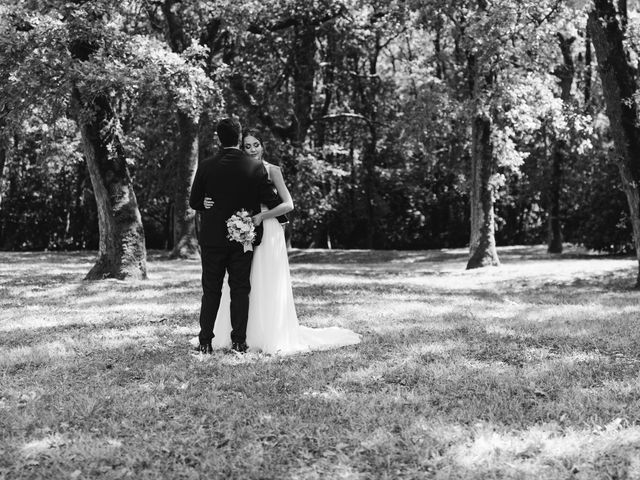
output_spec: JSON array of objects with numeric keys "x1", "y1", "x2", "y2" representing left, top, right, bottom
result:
[{"x1": 467, "y1": 115, "x2": 500, "y2": 269}]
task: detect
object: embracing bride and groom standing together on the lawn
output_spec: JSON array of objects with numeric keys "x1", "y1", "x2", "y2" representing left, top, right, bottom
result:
[{"x1": 189, "y1": 118, "x2": 360, "y2": 354}]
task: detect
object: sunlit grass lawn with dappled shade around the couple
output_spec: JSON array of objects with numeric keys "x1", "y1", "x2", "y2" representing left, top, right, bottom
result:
[{"x1": 0, "y1": 247, "x2": 640, "y2": 480}]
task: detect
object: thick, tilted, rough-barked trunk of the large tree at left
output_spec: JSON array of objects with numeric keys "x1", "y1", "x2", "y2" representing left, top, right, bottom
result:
[{"x1": 73, "y1": 88, "x2": 147, "y2": 280}]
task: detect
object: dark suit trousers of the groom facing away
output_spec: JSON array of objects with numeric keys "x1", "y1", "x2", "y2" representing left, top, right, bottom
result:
[{"x1": 199, "y1": 244, "x2": 253, "y2": 344}]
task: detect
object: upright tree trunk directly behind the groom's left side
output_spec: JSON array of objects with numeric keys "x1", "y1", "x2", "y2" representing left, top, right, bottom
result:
[{"x1": 170, "y1": 112, "x2": 200, "y2": 258}]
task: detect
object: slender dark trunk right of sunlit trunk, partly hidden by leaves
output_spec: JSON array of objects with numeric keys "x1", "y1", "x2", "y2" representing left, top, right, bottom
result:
[{"x1": 547, "y1": 34, "x2": 575, "y2": 253}]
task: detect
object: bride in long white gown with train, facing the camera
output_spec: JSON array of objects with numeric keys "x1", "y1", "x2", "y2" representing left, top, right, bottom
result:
[{"x1": 196, "y1": 130, "x2": 360, "y2": 354}]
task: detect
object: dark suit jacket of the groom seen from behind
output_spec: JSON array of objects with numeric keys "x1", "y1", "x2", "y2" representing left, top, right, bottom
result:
[{"x1": 189, "y1": 148, "x2": 286, "y2": 247}]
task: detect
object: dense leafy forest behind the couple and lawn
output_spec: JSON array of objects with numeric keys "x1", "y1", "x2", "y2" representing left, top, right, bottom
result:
[{"x1": 0, "y1": 0, "x2": 640, "y2": 284}]
